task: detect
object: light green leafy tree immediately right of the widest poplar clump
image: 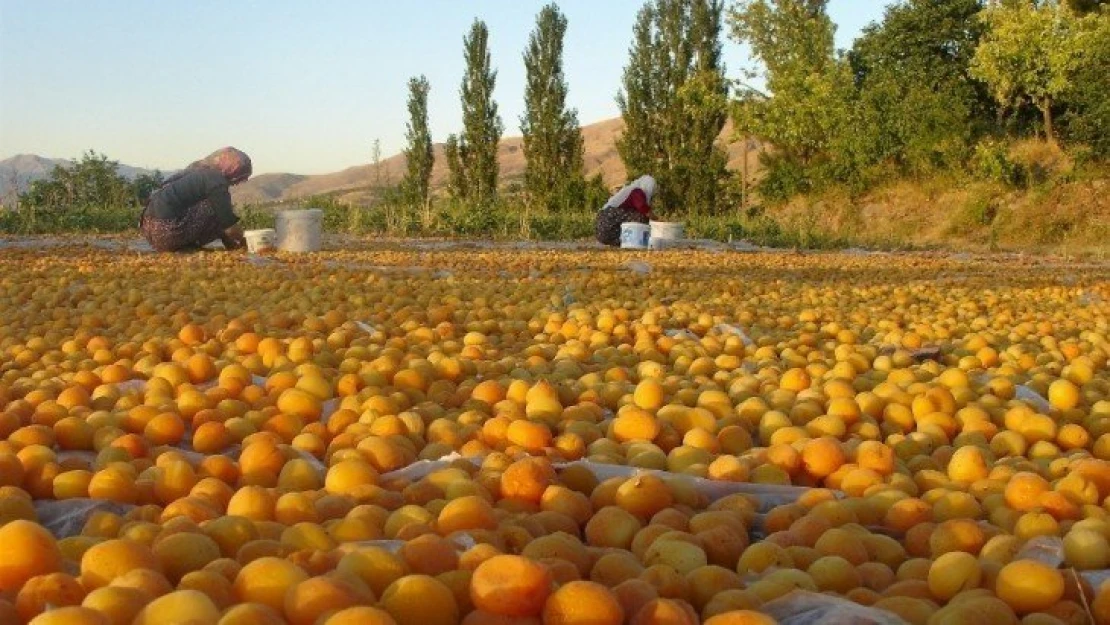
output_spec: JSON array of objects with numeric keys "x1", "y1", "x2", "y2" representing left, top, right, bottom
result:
[{"x1": 729, "y1": 0, "x2": 856, "y2": 198}]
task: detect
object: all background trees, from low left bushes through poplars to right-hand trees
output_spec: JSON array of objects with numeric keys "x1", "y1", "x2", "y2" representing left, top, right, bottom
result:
[{"x1": 20, "y1": 0, "x2": 1110, "y2": 225}]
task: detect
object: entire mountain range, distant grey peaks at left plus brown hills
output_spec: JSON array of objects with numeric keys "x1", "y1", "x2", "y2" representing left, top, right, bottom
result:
[{"x1": 0, "y1": 118, "x2": 759, "y2": 209}]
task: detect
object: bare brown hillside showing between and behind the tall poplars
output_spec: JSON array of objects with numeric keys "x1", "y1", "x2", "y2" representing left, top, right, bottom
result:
[{"x1": 232, "y1": 119, "x2": 757, "y2": 203}]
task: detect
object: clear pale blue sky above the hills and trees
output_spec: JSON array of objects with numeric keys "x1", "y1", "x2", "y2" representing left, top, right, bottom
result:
[{"x1": 0, "y1": 0, "x2": 889, "y2": 173}]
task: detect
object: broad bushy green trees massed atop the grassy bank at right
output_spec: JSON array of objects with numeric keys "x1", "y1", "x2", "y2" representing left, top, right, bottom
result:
[{"x1": 729, "y1": 0, "x2": 1110, "y2": 199}]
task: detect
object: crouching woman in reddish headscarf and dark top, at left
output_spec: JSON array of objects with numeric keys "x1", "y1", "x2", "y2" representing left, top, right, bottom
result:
[{"x1": 139, "y1": 148, "x2": 251, "y2": 252}]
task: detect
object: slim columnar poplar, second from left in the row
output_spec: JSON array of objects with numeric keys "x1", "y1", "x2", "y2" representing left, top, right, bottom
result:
[{"x1": 447, "y1": 20, "x2": 504, "y2": 208}]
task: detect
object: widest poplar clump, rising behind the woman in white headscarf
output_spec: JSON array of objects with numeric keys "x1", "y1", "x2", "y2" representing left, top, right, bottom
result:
[{"x1": 617, "y1": 0, "x2": 728, "y2": 214}]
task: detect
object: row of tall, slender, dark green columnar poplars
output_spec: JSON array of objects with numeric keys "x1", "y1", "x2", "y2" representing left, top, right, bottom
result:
[{"x1": 401, "y1": 0, "x2": 729, "y2": 219}]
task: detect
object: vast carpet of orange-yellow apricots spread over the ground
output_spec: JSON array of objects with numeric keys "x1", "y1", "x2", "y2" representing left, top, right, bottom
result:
[{"x1": 0, "y1": 241, "x2": 1110, "y2": 625}]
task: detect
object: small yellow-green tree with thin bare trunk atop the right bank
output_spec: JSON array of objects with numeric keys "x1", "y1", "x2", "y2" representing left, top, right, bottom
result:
[{"x1": 971, "y1": 0, "x2": 1082, "y2": 142}]
